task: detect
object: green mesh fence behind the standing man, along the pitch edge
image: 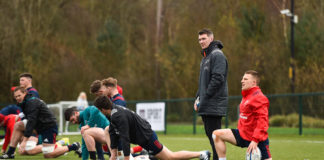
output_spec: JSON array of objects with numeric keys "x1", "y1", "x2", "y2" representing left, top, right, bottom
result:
[{"x1": 127, "y1": 92, "x2": 324, "y2": 135}]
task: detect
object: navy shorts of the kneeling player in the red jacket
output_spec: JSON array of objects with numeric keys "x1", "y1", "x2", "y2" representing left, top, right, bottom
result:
[{"x1": 232, "y1": 129, "x2": 271, "y2": 159}]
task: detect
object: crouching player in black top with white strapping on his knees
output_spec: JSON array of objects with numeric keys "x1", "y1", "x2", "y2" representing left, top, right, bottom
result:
[{"x1": 0, "y1": 87, "x2": 80, "y2": 159}]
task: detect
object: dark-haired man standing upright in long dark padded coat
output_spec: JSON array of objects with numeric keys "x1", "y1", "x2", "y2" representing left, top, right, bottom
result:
[{"x1": 194, "y1": 29, "x2": 228, "y2": 160}]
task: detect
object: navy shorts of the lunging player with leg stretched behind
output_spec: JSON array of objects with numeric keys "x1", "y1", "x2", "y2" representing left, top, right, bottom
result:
[{"x1": 140, "y1": 132, "x2": 163, "y2": 155}]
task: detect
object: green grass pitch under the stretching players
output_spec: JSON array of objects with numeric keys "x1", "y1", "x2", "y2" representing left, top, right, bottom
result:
[{"x1": 4, "y1": 125, "x2": 324, "y2": 160}]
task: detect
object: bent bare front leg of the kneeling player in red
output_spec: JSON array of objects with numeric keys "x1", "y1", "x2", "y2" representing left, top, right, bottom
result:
[{"x1": 213, "y1": 129, "x2": 236, "y2": 158}]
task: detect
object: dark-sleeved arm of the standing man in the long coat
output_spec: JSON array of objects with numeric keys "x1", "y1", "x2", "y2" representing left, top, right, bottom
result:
[{"x1": 206, "y1": 51, "x2": 227, "y2": 97}]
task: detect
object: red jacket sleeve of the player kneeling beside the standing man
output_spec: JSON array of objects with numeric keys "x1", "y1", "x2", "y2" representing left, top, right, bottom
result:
[{"x1": 252, "y1": 95, "x2": 269, "y2": 142}]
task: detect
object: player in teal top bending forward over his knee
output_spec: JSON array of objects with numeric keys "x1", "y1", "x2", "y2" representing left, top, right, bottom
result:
[{"x1": 64, "y1": 106, "x2": 110, "y2": 160}]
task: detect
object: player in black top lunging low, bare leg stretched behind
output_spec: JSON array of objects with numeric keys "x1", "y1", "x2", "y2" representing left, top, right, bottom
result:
[{"x1": 94, "y1": 96, "x2": 210, "y2": 160}]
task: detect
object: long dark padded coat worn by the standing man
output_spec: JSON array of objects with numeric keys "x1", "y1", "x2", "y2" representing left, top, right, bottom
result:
[{"x1": 196, "y1": 41, "x2": 228, "y2": 116}]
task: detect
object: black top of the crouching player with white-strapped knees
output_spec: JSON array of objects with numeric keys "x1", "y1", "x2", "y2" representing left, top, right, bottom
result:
[{"x1": 19, "y1": 94, "x2": 57, "y2": 137}]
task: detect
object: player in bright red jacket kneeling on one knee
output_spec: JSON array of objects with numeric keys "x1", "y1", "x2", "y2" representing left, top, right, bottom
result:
[{"x1": 213, "y1": 70, "x2": 272, "y2": 160}]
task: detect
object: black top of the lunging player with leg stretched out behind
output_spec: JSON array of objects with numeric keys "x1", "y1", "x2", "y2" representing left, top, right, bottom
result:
[{"x1": 109, "y1": 104, "x2": 153, "y2": 156}]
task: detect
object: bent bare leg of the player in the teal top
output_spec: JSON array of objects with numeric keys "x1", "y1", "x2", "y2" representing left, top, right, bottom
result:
[{"x1": 82, "y1": 127, "x2": 106, "y2": 159}]
